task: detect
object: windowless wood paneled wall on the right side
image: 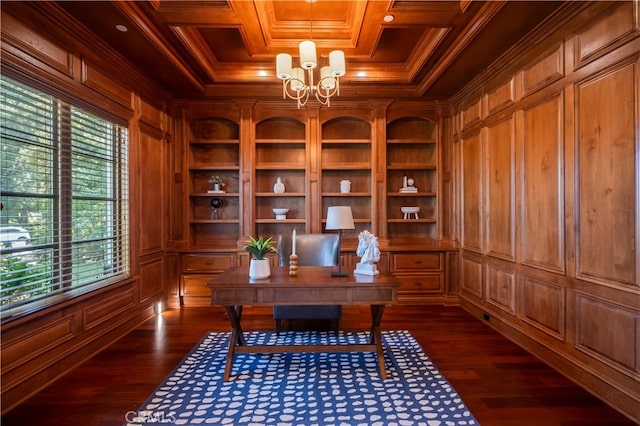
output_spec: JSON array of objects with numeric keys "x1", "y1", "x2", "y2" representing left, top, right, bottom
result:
[{"x1": 454, "y1": 2, "x2": 640, "y2": 421}]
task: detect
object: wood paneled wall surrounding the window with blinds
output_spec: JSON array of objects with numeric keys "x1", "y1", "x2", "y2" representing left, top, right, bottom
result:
[{"x1": 1, "y1": 9, "x2": 169, "y2": 412}]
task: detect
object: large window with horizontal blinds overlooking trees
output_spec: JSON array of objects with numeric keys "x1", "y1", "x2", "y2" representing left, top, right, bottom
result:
[{"x1": 0, "y1": 77, "x2": 129, "y2": 318}]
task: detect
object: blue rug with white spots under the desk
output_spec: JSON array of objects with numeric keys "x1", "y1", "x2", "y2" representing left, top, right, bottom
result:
[{"x1": 126, "y1": 331, "x2": 478, "y2": 426}]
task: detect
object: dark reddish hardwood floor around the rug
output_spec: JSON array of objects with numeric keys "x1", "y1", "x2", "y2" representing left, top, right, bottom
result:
[{"x1": 1, "y1": 306, "x2": 634, "y2": 426}]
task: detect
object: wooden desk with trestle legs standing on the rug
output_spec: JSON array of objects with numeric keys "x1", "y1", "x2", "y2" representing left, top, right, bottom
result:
[{"x1": 207, "y1": 266, "x2": 401, "y2": 381}]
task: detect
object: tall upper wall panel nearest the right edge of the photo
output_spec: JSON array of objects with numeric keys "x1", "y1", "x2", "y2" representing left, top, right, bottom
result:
[{"x1": 576, "y1": 63, "x2": 638, "y2": 286}]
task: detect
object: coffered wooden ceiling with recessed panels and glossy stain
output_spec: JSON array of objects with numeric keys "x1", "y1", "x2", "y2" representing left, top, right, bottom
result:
[{"x1": 57, "y1": 0, "x2": 563, "y2": 100}]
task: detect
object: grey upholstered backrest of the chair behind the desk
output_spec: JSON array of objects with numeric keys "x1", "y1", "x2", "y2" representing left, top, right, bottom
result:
[{"x1": 278, "y1": 234, "x2": 339, "y2": 266}]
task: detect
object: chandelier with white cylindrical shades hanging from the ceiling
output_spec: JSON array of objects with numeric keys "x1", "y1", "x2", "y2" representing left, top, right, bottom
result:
[{"x1": 276, "y1": 0, "x2": 347, "y2": 108}]
